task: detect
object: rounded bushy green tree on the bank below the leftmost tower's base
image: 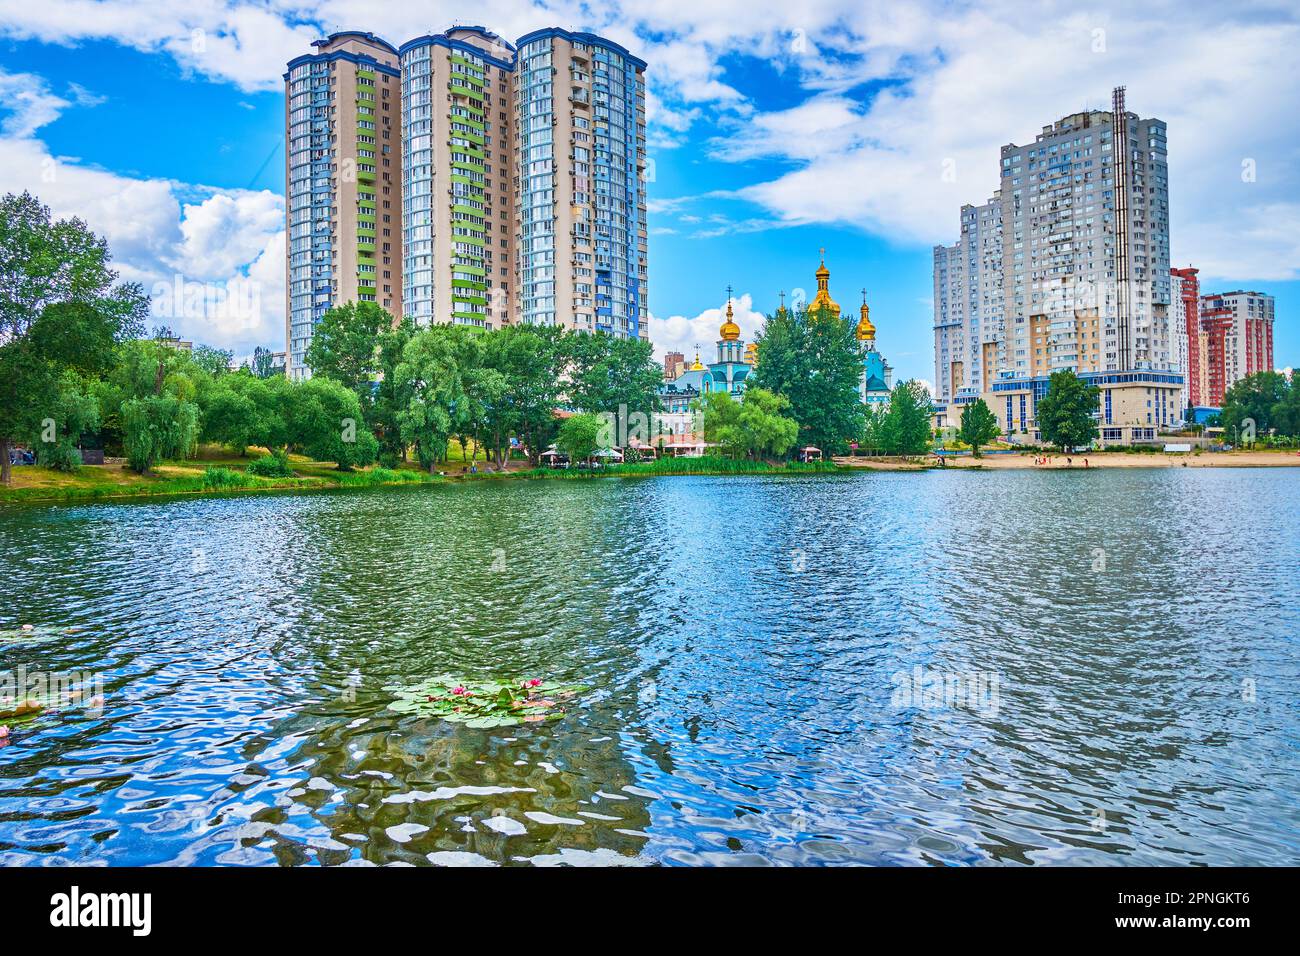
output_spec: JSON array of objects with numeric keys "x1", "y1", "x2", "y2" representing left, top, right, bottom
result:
[{"x1": 285, "y1": 377, "x2": 380, "y2": 471}]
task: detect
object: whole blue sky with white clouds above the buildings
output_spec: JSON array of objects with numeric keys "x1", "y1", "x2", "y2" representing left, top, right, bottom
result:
[{"x1": 0, "y1": 0, "x2": 1300, "y2": 378}]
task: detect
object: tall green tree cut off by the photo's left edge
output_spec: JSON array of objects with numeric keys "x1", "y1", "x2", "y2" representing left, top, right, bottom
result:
[{"x1": 0, "y1": 193, "x2": 148, "y2": 484}]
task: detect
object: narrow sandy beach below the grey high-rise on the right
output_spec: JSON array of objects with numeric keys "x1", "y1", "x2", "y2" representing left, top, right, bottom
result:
[{"x1": 835, "y1": 450, "x2": 1300, "y2": 471}]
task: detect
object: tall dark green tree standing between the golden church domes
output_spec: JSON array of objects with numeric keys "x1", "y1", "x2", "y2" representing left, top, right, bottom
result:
[{"x1": 748, "y1": 310, "x2": 866, "y2": 453}]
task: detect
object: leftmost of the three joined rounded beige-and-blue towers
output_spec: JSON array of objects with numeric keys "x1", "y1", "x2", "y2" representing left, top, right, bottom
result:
[{"x1": 285, "y1": 33, "x2": 402, "y2": 377}]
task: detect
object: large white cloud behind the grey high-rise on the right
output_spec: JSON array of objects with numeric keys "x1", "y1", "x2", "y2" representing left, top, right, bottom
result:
[{"x1": 712, "y1": 4, "x2": 1300, "y2": 278}]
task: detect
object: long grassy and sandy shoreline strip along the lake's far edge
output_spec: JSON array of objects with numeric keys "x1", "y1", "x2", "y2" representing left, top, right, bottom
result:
[{"x1": 0, "y1": 450, "x2": 1300, "y2": 506}]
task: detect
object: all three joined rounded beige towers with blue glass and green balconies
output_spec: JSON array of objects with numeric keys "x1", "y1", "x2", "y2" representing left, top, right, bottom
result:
[{"x1": 285, "y1": 26, "x2": 647, "y2": 376}]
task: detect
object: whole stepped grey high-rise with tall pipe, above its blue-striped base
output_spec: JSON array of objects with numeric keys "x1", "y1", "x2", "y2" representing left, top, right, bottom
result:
[{"x1": 935, "y1": 87, "x2": 1177, "y2": 392}]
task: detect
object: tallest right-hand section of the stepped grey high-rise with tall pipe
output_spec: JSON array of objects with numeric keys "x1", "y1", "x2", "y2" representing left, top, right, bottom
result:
[{"x1": 1001, "y1": 87, "x2": 1173, "y2": 375}]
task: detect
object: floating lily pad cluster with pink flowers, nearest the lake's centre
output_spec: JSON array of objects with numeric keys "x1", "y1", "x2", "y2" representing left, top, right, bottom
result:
[{"x1": 384, "y1": 678, "x2": 586, "y2": 728}]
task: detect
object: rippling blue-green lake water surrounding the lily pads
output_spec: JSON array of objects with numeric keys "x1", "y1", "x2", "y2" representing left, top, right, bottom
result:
[{"x1": 0, "y1": 468, "x2": 1300, "y2": 865}]
